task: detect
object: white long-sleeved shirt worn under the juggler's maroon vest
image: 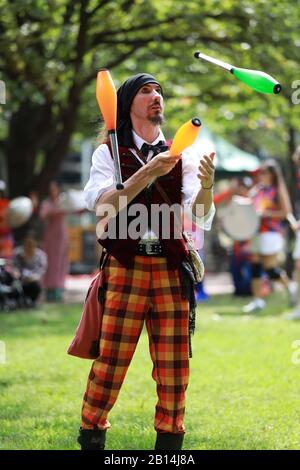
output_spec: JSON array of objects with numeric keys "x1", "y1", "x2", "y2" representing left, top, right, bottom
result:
[{"x1": 84, "y1": 131, "x2": 216, "y2": 233}]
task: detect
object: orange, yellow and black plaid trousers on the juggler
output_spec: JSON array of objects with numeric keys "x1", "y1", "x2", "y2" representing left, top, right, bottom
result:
[{"x1": 82, "y1": 256, "x2": 189, "y2": 433}]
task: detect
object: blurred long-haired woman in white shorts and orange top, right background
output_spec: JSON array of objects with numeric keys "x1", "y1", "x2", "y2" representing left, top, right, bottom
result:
[{"x1": 243, "y1": 160, "x2": 294, "y2": 313}]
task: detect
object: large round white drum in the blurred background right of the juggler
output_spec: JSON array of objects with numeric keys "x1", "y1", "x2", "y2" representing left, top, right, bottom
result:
[{"x1": 221, "y1": 196, "x2": 260, "y2": 241}]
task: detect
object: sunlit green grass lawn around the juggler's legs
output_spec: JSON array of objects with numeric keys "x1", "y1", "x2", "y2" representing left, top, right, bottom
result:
[{"x1": 0, "y1": 293, "x2": 300, "y2": 450}]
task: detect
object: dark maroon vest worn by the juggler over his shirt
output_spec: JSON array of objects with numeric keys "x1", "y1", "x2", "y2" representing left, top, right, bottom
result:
[{"x1": 98, "y1": 144, "x2": 188, "y2": 270}]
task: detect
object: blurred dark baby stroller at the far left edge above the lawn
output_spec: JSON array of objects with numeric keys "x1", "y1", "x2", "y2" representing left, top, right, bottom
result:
[{"x1": 0, "y1": 258, "x2": 26, "y2": 312}]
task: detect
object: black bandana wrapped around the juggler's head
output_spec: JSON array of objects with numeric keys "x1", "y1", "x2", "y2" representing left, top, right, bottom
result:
[{"x1": 117, "y1": 73, "x2": 160, "y2": 147}]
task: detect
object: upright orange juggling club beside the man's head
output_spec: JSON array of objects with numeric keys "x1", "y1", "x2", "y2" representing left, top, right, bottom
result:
[{"x1": 96, "y1": 69, "x2": 124, "y2": 189}]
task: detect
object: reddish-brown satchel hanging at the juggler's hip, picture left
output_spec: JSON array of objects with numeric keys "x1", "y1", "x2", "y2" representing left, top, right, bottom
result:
[{"x1": 67, "y1": 253, "x2": 107, "y2": 359}]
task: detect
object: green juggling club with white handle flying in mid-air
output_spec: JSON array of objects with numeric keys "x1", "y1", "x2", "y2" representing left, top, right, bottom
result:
[{"x1": 194, "y1": 52, "x2": 281, "y2": 94}]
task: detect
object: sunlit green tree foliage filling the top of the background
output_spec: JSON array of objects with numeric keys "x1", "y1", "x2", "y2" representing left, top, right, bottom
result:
[{"x1": 0, "y1": 0, "x2": 300, "y2": 197}]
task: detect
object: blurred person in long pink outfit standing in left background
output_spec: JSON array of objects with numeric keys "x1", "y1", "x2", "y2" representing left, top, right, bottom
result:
[{"x1": 40, "y1": 181, "x2": 69, "y2": 302}]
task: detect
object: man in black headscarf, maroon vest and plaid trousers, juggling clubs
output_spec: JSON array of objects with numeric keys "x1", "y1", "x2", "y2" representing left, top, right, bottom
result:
[{"x1": 78, "y1": 73, "x2": 215, "y2": 450}]
